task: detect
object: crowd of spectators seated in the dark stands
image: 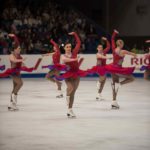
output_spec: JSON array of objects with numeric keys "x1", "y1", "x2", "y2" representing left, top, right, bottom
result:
[{"x1": 0, "y1": 0, "x2": 100, "y2": 54}]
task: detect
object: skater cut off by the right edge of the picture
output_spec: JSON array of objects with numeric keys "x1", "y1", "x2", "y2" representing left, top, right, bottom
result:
[{"x1": 140, "y1": 40, "x2": 150, "y2": 81}]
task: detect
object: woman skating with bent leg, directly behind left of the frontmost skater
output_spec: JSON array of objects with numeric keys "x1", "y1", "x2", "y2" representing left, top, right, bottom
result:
[{"x1": 42, "y1": 40, "x2": 65, "y2": 98}]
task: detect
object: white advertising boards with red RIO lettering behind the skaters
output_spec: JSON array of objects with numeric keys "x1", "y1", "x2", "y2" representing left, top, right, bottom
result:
[{"x1": 0, "y1": 54, "x2": 149, "y2": 76}]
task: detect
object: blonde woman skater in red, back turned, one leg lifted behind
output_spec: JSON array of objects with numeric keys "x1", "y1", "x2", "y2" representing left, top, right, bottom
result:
[{"x1": 106, "y1": 30, "x2": 136, "y2": 109}]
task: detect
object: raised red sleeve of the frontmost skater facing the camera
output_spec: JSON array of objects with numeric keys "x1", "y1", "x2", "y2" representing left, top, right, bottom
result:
[{"x1": 72, "y1": 33, "x2": 81, "y2": 57}]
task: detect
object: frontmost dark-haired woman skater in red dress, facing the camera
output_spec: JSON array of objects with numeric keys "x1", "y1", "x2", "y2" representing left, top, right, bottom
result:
[{"x1": 59, "y1": 32, "x2": 87, "y2": 118}]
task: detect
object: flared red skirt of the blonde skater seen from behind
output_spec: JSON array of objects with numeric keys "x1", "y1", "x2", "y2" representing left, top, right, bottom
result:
[{"x1": 105, "y1": 64, "x2": 135, "y2": 75}]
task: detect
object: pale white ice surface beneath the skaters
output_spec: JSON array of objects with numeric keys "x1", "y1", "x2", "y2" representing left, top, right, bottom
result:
[{"x1": 0, "y1": 78, "x2": 150, "y2": 150}]
